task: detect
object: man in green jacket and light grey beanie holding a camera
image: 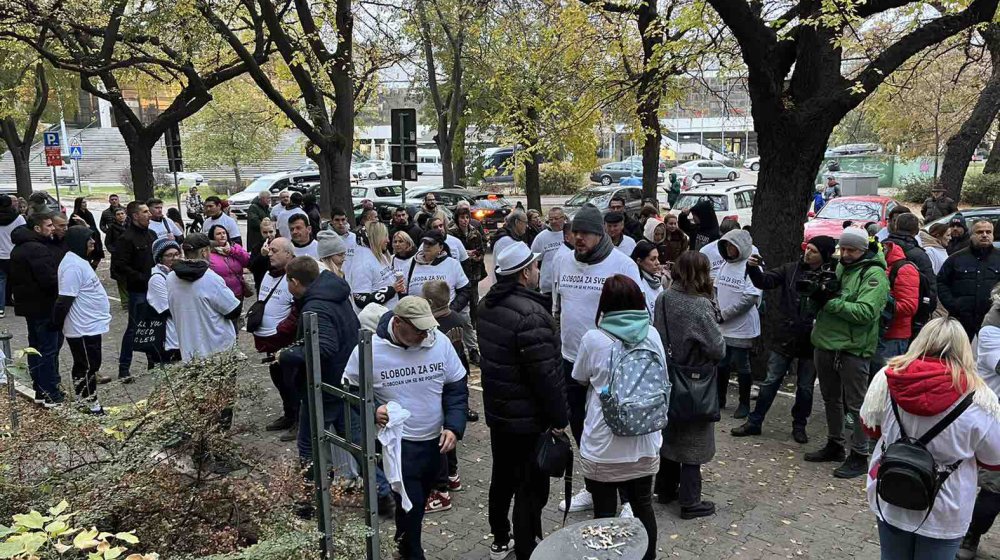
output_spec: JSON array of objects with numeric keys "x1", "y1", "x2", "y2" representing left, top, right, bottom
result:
[{"x1": 805, "y1": 227, "x2": 889, "y2": 478}]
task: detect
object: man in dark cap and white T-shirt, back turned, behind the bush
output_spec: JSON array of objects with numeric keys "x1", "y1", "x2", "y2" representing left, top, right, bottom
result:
[{"x1": 167, "y1": 233, "x2": 241, "y2": 362}]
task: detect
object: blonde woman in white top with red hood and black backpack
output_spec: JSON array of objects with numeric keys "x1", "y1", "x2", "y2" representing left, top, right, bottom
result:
[{"x1": 860, "y1": 318, "x2": 1000, "y2": 560}]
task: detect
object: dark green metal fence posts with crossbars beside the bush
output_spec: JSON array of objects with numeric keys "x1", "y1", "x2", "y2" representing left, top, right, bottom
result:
[{"x1": 302, "y1": 313, "x2": 379, "y2": 560}]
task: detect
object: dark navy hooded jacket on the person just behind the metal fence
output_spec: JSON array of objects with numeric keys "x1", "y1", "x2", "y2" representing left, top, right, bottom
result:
[{"x1": 278, "y1": 270, "x2": 361, "y2": 406}]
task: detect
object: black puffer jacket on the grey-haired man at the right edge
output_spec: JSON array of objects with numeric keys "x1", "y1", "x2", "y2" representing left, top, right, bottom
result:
[{"x1": 938, "y1": 245, "x2": 1000, "y2": 340}]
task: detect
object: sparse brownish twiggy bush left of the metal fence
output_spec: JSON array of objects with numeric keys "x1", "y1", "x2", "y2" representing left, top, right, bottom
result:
[{"x1": 0, "y1": 353, "x2": 352, "y2": 560}]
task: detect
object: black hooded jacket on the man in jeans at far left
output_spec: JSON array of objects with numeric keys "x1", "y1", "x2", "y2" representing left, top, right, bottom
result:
[{"x1": 7, "y1": 225, "x2": 59, "y2": 318}]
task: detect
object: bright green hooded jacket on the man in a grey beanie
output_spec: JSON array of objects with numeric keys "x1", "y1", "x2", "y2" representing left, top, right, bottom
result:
[{"x1": 811, "y1": 251, "x2": 889, "y2": 358}]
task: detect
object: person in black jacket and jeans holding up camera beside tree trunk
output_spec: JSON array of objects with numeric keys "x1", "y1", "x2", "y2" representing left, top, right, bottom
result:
[{"x1": 732, "y1": 235, "x2": 837, "y2": 443}]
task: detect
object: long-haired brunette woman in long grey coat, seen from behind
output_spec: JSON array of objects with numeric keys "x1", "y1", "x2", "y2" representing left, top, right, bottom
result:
[{"x1": 653, "y1": 251, "x2": 726, "y2": 519}]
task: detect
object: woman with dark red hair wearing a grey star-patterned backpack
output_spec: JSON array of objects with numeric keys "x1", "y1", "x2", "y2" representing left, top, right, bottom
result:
[{"x1": 573, "y1": 274, "x2": 669, "y2": 560}]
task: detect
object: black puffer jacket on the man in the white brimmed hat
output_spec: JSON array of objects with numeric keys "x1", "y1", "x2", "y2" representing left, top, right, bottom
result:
[{"x1": 478, "y1": 282, "x2": 567, "y2": 434}]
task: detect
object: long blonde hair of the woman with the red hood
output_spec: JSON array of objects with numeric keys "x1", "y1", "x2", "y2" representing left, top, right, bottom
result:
[{"x1": 888, "y1": 317, "x2": 985, "y2": 393}]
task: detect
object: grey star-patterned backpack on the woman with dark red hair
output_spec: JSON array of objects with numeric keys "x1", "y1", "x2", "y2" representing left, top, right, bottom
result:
[{"x1": 600, "y1": 335, "x2": 670, "y2": 436}]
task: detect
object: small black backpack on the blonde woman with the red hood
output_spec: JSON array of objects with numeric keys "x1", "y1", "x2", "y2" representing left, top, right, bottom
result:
[{"x1": 875, "y1": 392, "x2": 975, "y2": 529}]
